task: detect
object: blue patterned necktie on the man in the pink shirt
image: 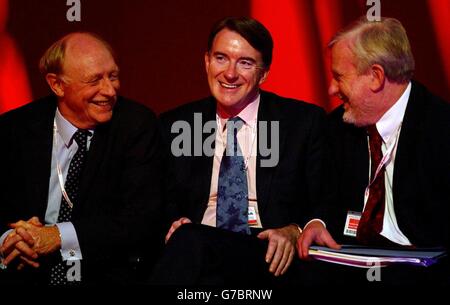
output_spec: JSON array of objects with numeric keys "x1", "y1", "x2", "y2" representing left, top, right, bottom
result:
[{"x1": 216, "y1": 117, "x2": 250, "y2": 234}]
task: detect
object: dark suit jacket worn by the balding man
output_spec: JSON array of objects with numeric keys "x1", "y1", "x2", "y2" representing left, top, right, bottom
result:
[{"x1": 0, "y1": 96, "x2": 163, "y2": 282}]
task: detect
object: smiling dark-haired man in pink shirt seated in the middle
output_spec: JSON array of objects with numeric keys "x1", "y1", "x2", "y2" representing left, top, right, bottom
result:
[{"x1": 152, "y1": 18, "x2": 329, "y2": 284}]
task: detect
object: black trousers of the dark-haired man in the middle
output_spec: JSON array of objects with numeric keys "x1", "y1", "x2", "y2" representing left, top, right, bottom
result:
[{"x1": 150, "y1": 224, "x2": 295, "y2": 287}]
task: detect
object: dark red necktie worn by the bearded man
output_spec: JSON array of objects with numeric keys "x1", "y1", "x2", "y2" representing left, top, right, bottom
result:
[{"x1": 356, "y1": 125, "x2": 385, "y2": 246}]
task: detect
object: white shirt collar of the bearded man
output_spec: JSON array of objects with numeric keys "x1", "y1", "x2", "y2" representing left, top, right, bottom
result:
[{"x1": 376, "y1": 82, "x2": 411, "y2": 143}]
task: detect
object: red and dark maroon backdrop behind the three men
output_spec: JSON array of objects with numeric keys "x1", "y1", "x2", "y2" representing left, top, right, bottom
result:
[{"x1": 0, "y1": 0, "x2": 450, "y2": 112}]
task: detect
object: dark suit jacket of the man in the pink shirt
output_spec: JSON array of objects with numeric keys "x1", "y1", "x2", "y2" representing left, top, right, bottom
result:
[{"x1": 160, "y1": 91, "x2": 329, "y2": 229}]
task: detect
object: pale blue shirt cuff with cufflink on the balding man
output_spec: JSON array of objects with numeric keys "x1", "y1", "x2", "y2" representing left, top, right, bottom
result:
[{"x1": 56, "y1": 222, "x2": 83, "y2": 261}]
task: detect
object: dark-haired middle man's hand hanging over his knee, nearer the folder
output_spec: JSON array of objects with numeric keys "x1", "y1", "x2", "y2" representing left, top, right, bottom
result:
[{"x1": 257, "y1": 225, "x2": 299, "y2": 276}]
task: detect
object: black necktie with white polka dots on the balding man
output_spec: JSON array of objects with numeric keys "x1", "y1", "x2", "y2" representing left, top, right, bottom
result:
[{"x1": 50, "y1": 129, "x2": 89, "y2": 285}]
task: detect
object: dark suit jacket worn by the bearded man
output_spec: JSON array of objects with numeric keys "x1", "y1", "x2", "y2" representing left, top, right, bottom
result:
[{"x1": 327, "y1": 82, "x2": 450, "y2": 247}]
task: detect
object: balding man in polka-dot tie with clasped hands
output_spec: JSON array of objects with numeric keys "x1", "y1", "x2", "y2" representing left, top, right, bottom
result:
[{"x1": 0, "y1": 33, "x2": 163, "y2": 284}]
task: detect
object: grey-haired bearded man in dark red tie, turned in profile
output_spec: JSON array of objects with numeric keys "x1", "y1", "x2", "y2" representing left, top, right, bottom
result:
[{"x1": 298, "y1": 18, "x2": 450, "y2": 282}]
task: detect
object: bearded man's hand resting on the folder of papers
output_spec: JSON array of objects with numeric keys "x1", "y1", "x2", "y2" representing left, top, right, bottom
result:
[{"x1": 297, "y1": 221, "x2": 341, "y2": 259}]
